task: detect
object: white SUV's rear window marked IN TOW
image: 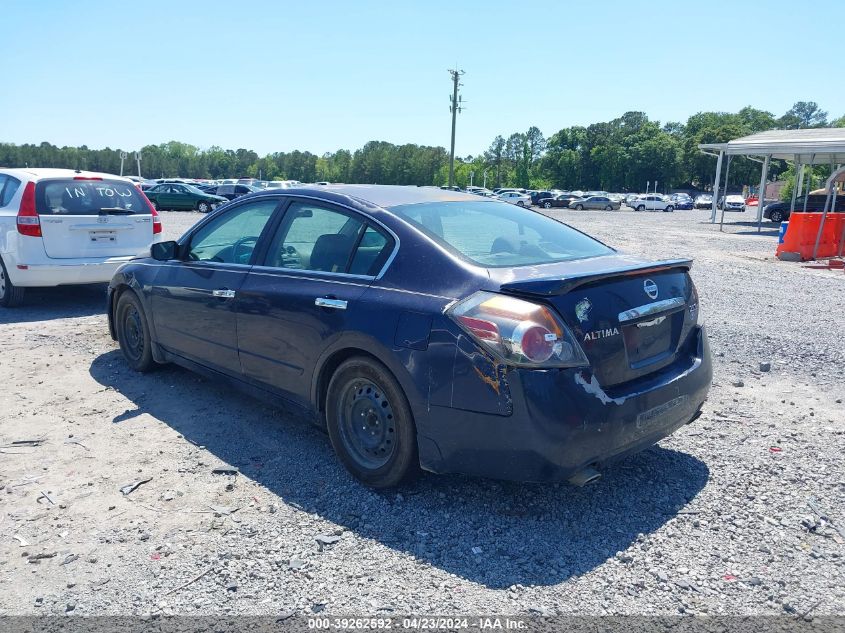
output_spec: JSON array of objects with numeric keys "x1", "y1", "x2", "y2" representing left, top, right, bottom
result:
[{"x1": 35, "y1": 178, "x2": 150, "y2": 215}]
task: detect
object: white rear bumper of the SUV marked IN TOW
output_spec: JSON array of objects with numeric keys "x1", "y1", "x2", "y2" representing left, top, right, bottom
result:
[{"x1": 3, "y1": 255, "x2": 136, "y2": 288}]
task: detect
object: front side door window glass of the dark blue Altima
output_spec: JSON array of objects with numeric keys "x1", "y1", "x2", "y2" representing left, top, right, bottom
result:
[{"x1": 188, "y1": 200, "x2": 278, "y2": 264}]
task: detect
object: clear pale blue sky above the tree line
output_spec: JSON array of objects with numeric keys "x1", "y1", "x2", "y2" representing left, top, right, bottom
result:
[{"x1": 0, "y1": 0, "x2": 845, "y2": 156}]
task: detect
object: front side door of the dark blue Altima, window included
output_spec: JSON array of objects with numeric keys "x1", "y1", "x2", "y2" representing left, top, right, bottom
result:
[{"x1": 151, "y1": 198, "x2": 279, "y2": 375}]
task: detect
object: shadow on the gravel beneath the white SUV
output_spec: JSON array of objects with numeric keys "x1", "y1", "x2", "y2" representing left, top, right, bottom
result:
[{"x1": 0, "y1": 284, "x2": 108, "y2": 323}]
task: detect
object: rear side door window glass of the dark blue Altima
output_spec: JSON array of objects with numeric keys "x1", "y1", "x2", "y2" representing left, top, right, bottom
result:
[{"x1": 267, "y1": 202, "x2": 364, "y2": 273}]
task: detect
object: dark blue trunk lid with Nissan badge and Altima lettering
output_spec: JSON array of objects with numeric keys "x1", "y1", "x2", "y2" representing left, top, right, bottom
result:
[{"x1": 500, "y1": 255, "x2": 695, "y2": 387}]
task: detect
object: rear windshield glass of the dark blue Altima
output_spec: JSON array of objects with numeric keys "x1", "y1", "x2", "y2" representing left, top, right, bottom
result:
[{"x1": 391, "y1": 200, "x2": 615, "y2": 267}]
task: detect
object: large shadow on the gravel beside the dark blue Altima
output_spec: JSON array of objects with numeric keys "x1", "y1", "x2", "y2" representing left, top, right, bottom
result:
[{"x1": 90, "y1": 351, "x2": 709, "y2": 589}]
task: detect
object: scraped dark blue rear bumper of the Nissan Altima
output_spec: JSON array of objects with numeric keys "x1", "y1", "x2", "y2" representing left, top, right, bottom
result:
[{"x1": 419, "y1": 328, "x2": 713, "y2": 482}]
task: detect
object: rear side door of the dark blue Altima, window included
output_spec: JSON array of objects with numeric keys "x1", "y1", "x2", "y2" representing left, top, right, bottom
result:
[{"x1": 238, "y1": 199, "x2": 395, "y2": 404}]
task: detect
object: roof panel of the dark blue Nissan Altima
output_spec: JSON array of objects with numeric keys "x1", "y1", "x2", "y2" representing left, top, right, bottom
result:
[{"x1": 251, "y1": 185, "x2": 487, "y2": 209}]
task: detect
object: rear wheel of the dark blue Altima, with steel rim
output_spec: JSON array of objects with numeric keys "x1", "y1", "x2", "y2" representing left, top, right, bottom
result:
[{"x1": 326, "y1": 356, "x2": 419, "y2": 488}]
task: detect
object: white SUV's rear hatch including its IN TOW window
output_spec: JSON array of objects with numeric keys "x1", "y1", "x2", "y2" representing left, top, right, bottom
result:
[{"x1": 35, "y1": 177, "x2": 153, "y2": 259}]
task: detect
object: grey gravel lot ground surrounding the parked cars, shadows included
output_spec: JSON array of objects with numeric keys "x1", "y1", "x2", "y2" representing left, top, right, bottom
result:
[{"x1": 0, "y1": 210, "x2": 845, "y2": 616}]
